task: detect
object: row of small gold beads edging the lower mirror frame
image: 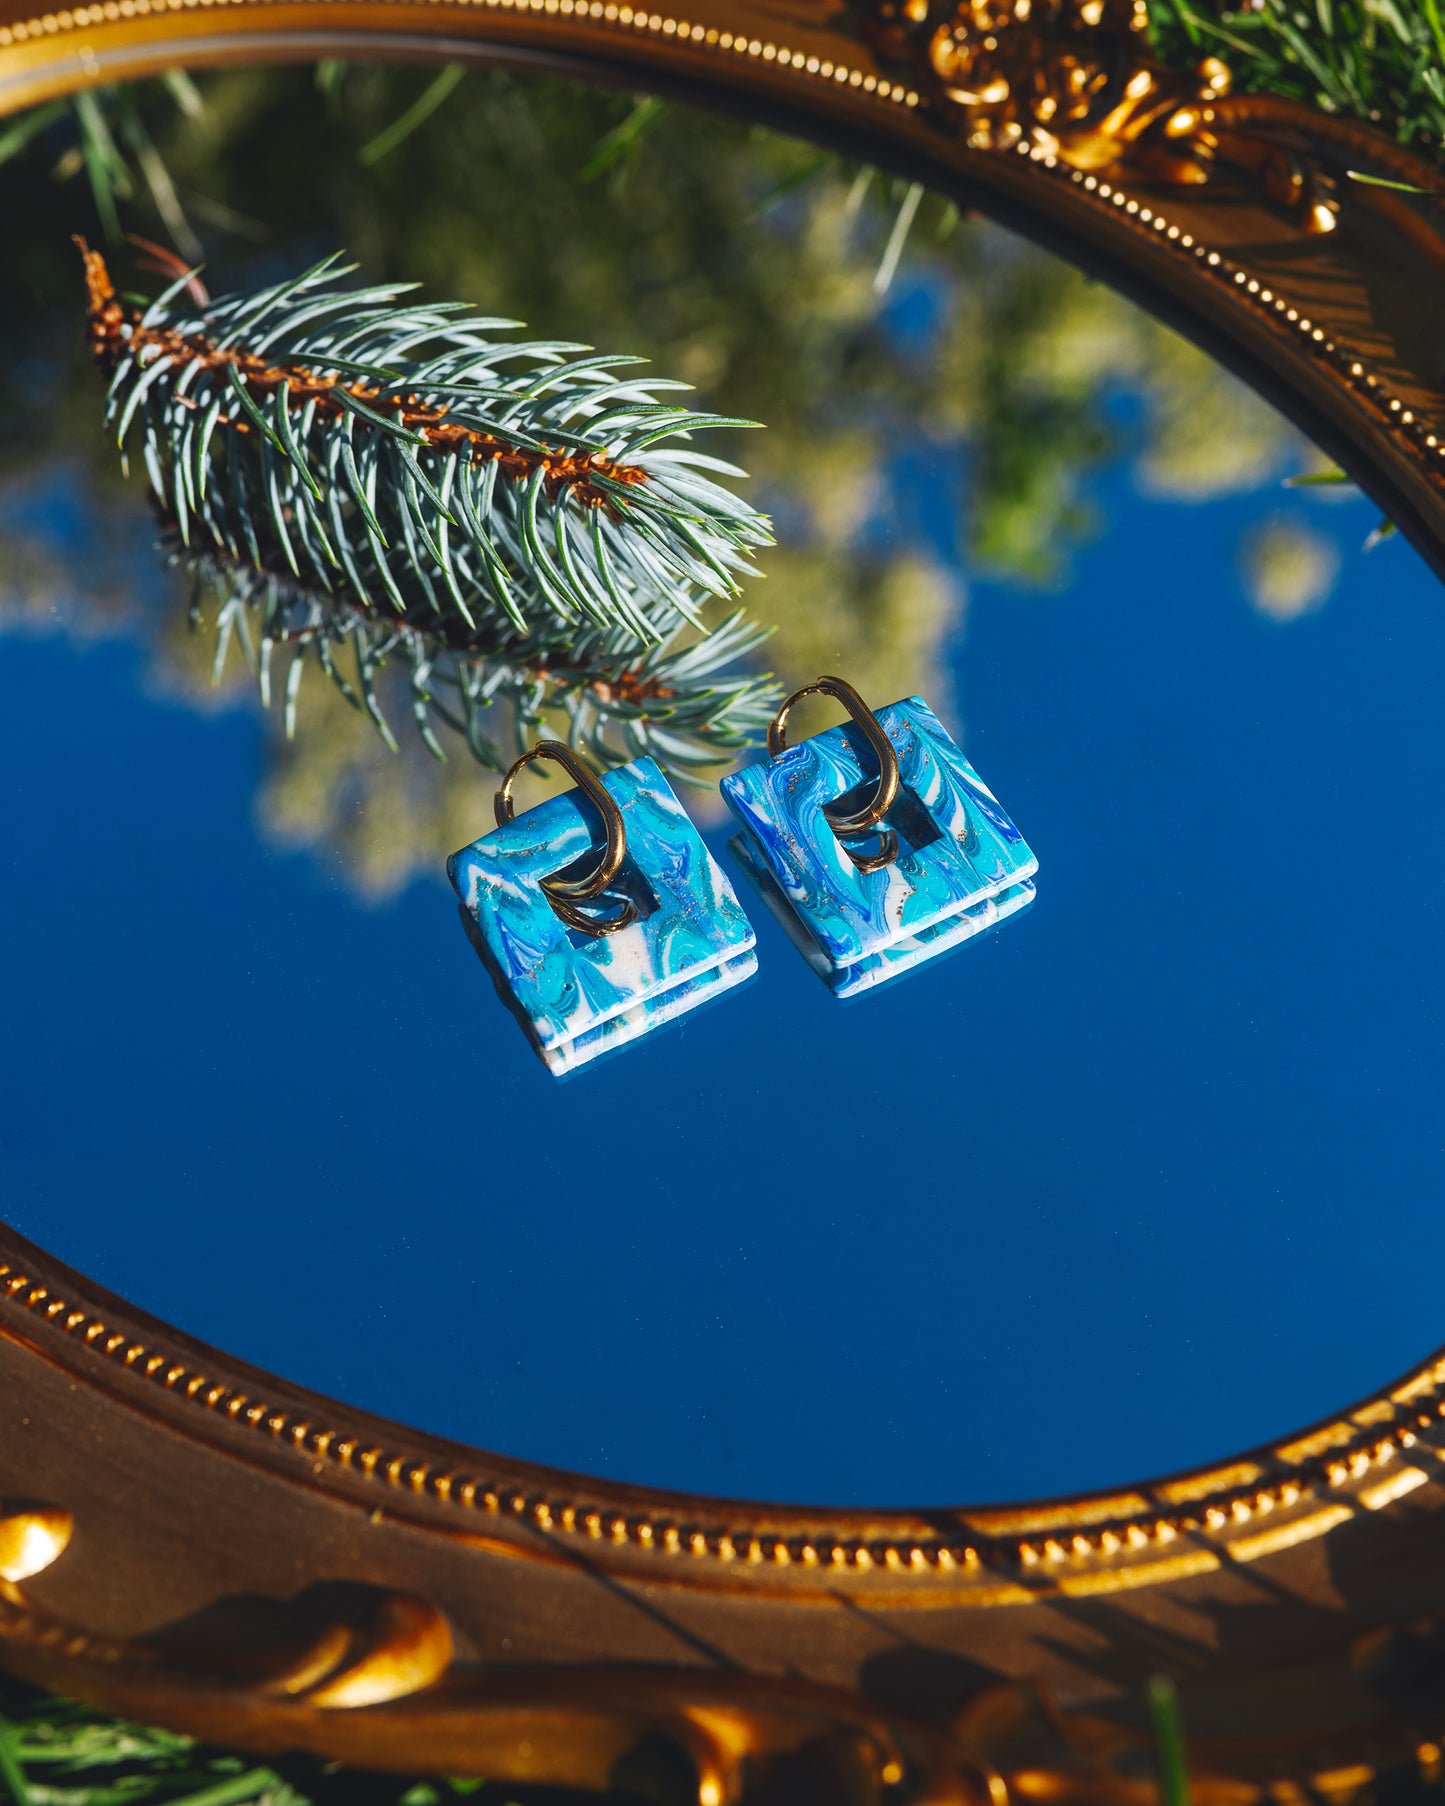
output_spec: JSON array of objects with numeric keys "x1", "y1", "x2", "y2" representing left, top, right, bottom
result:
[{"x1": 0, "y1": 1262, "x2": 1445, "y2": 1582}]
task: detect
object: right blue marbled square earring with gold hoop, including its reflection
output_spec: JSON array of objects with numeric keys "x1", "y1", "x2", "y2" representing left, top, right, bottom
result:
[{"x1": 723, "y1": 677, "x2": 1039, "y2": 997}]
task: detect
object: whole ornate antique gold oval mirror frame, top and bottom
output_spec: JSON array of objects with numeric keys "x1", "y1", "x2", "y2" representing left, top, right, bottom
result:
[{"x1": 0, "y1": 0, "x2": 1445, "y2": 1806}]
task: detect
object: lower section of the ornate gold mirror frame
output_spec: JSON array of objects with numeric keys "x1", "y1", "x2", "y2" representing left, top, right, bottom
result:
[{"x1": 0, "y1": 1237, "x2": 1445, "y2": 1806}]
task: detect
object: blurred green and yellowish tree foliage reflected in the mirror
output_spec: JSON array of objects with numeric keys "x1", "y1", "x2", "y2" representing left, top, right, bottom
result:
[{"x1": 0, "y1": 65, "x2": 1304, "y2": 894}]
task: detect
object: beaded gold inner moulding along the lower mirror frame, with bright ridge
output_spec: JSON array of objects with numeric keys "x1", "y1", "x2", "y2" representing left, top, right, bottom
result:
[{"x1": 0, "y1": 1256, "x2": 1445, "y2": 1596}]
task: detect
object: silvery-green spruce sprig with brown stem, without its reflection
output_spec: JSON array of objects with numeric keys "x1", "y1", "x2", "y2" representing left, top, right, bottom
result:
[{"x1": 83, "y1": 247, "x2": 771, "y2": 643}]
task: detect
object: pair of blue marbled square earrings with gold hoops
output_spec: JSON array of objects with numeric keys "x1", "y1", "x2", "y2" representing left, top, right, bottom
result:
[{"x1": 446, "y1": 677, "x2": 1039, "y2": 1075}]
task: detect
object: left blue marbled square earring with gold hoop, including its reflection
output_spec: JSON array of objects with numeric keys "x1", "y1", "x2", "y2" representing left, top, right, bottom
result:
[{"x1": 446, "y1": 740, "x2": 757, "y2": 1073}]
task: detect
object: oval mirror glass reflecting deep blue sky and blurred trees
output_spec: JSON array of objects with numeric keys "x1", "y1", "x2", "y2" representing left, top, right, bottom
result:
[{"x1": 0, "y1": 65, "x2": 1445, "y2": 1504}]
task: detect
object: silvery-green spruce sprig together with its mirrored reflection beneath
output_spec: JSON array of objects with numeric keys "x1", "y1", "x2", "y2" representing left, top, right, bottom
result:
[{"x1": 81, "y1": 246, "x2": 777, "y2": 777}]
